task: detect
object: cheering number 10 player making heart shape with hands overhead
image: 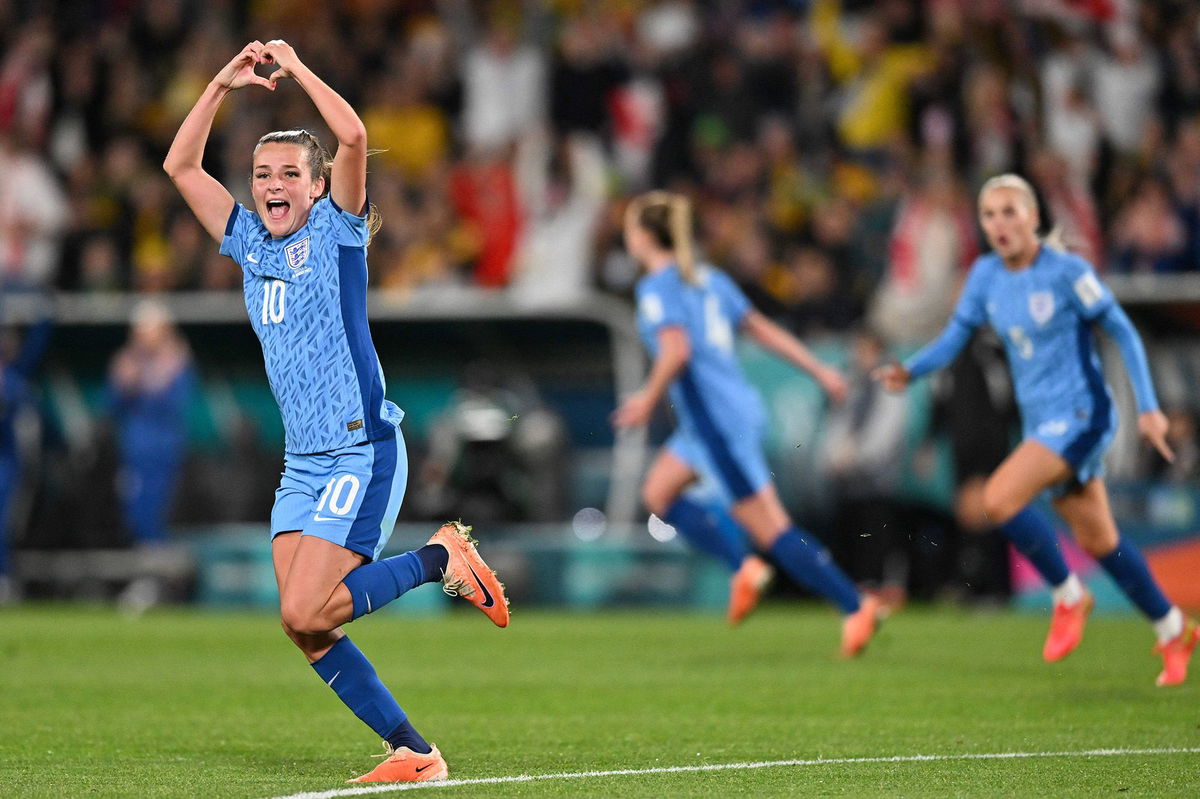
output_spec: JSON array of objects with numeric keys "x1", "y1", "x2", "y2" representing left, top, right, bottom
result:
[{"x1": 163, "y1": 40, "x2": 509, "y2": 782}]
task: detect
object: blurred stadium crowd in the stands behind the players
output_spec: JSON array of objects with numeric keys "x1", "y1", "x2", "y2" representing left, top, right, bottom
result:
[{"x1": 0, "y1": 0, "x2": 1200, "y2": 604}]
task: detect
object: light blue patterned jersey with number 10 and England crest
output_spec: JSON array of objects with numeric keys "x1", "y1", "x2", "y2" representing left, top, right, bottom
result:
[{"x1": 221, "y1": 197, "x2": 403, "y2": 455}]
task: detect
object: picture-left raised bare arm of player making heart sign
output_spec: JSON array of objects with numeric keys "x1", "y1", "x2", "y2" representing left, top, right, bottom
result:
[{"x1": 162, "y1": 42, "x2": 274, "y2": 241}]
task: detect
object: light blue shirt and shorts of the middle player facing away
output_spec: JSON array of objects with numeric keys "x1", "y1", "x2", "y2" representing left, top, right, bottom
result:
[{"x1": 635, "y1": 265, "x2": 770, "y2": 500}]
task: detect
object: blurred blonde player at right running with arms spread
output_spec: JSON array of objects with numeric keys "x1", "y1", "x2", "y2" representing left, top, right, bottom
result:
[{"x1": 877, "y1": 174, "x2": 1200, "y2": 685}]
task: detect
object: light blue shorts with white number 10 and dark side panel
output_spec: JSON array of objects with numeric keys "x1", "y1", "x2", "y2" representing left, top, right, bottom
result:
[{"x1": 271, "y1": 427, "x2": 408, "y2": 560}]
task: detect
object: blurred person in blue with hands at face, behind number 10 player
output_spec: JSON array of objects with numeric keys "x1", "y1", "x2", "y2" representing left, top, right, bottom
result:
[{"x1": 108, "y1": 300, "x2": 194, "y2": 546}]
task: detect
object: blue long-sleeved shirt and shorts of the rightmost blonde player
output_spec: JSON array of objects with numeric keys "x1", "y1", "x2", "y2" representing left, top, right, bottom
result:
[{"x1": 906, "y1": 246, "x2": 1158, "y2": 482}]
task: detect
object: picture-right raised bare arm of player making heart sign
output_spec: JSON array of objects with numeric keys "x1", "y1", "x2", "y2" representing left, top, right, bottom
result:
[{"x1": 263, "y1": 38, "x2": 367, "y2": 215}]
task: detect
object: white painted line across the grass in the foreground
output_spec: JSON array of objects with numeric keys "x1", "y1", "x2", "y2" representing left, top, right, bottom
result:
[{"x1": 275, "y1": 747, "x2": 1200, "y2": 799}]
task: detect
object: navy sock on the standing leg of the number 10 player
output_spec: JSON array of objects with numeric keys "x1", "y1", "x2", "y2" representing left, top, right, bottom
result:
[{"x1": 312, "y1": 636, "x2": 431, "y2": 753}]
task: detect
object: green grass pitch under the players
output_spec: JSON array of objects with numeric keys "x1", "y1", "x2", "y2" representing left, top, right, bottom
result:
[{"x1": 0, "y1": 605, "x2": 1200, "y2": 799}]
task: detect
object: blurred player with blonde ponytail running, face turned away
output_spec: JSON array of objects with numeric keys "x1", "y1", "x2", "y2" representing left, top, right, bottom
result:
[{"x1": 613, "y1": 192, "x2": 880, "y2": 657}]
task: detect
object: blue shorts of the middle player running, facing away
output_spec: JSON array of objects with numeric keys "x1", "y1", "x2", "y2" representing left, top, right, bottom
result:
[{"x1": 665, "y1": 426, "x2": 770, "y2": 504}]
